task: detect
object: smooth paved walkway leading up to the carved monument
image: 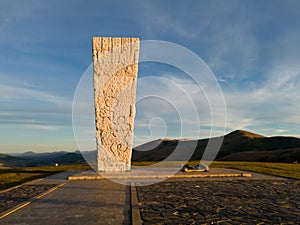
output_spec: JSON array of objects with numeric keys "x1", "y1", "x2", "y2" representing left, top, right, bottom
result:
[{"x1": 0, "y1": 171, "x2": 131, "y2": 225}]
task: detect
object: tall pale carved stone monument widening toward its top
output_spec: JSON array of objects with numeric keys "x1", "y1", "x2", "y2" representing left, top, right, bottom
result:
[{"x1": 93, "y1": 37, "x2": 139, "y2": 171}]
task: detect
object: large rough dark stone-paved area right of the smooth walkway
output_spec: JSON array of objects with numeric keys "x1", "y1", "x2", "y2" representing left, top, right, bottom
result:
[{"x1": 137, "y1": 180, "x2": 300, "y2": 224}]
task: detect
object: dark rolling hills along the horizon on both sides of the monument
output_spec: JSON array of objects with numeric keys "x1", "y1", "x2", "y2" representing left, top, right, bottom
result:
[{"x1": 0, "y1": 130, "x2": 300, "y2": 168}]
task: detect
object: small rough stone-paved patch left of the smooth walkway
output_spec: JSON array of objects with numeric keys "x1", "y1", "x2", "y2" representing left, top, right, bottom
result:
[{"x1": 0, "y1": 184, "x2": 57, "y2": 213}]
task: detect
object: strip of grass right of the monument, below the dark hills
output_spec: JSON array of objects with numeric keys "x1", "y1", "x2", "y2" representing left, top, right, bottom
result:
[{"x1": 133, "y1": 161, "x2": 300, "y2": 179}]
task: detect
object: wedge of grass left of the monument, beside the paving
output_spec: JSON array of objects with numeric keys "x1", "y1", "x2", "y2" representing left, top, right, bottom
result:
[{"x1": 0, "y1": 165, "x2": 90, "y2": 190}]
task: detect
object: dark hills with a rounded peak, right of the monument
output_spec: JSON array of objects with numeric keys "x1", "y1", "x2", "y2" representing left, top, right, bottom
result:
[{"x1": 132, "y1": 130, "x2": 300, "y2": 162}]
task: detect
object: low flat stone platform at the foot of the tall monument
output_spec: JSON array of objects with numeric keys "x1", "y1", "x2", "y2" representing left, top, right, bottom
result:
[{"x1": 68, "y1": 168, "x2": 252, "y2": 182}]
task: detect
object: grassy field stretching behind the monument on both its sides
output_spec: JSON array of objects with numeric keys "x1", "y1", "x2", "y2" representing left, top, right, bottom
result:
[{"x1": 0, "y1": 161, "x2": 300, "y2": 190}]
